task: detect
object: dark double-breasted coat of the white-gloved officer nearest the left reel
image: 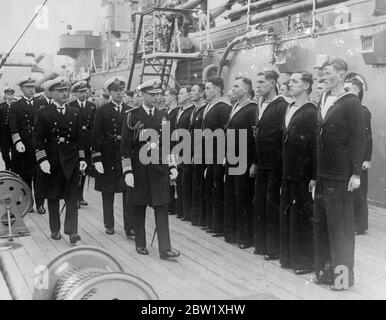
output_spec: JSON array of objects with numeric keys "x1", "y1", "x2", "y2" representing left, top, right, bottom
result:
[{"x1": 33, "y1": 104, "x2": 85, "y2": 200}]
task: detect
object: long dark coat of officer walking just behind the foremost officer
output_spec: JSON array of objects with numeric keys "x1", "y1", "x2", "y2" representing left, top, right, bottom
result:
[{"x1": 92, "y1": 102, "x2": 130, "y2": 193}]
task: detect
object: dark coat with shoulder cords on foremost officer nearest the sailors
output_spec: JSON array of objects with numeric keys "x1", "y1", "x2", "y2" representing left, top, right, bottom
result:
[{"x1": 121, "y1": 107, "x2": 175, "y2": 206}]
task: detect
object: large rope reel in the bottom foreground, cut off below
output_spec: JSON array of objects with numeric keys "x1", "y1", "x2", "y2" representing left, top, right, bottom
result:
[{"x1": 33, "y1": 247, "x2": 158, "y2": 300}]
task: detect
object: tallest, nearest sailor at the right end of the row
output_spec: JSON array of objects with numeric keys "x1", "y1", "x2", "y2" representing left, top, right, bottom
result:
[{"x1": 314, "y1": 58, "x2": 365, "y2": 291}]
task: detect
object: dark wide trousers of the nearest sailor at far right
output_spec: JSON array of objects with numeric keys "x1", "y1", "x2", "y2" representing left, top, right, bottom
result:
[{"x1": 314, "y1": 177, "x2": 355, "y2": 286}]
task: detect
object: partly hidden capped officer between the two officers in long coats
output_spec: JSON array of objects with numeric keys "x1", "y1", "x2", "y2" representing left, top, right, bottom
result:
[{"x1": 69, "y1": 81, "x2": 96, "y2": 208}]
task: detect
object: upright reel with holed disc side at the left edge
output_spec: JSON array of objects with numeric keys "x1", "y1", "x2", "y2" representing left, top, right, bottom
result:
[{"x1": 0, "y1": 171, "x2": 32, "y2": 249}]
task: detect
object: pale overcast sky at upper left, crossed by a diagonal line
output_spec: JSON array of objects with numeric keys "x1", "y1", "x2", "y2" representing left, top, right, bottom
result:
[{"x1": 0, "y1": 0, "x2": 105, "y2": 54}]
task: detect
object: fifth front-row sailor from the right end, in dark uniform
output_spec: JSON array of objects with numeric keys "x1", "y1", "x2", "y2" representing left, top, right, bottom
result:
[{"x1": 202, "y1": 78, "x2": 231, "y2": 237}]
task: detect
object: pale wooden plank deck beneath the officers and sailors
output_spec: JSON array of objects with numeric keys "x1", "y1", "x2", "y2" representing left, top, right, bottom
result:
[{"x1": 0, "y1": 180, "x2": 386, "y2": 300}]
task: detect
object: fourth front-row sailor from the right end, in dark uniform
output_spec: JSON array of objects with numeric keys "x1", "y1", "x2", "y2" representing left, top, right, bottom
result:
[{"x1": 224, "y1": 77, "x2": 258, "y2": 249}]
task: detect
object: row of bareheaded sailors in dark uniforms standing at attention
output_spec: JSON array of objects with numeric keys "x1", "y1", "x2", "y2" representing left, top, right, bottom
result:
[{"x1": 166, "y1": 59, "x2": 371, "y2": 290}]
